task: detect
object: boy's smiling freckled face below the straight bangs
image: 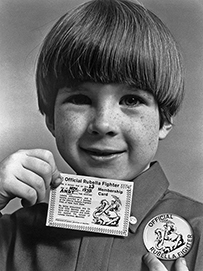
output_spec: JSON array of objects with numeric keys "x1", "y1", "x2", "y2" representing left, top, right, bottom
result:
[{"x1": 47, "y1": 82, "x2": 169, "y2": 180}]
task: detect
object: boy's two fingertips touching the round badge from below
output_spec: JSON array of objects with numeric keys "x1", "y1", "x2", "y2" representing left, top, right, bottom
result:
[{"x1": 144, "y1": 253, "x2": 189, "y2": 271}]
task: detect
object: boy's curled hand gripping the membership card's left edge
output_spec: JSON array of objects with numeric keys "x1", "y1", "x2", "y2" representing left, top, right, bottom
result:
[{"x1": 0, "y1": 149, "x2": 61, "y2": 210}]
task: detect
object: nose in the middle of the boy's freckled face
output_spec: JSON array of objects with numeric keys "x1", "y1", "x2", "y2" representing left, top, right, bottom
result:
[{"x1": 88, "y1": 106, "x2": 118, "y2": 136}]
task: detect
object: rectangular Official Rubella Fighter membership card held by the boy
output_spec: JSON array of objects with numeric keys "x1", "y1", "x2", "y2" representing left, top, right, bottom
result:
[{"x1": 46, "y1": 174, "x2": 133, "y2": 236}]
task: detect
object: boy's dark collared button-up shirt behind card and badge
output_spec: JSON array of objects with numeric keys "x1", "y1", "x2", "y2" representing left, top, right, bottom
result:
[{"x1": 0, "y1": 163, "x2": 203, "y2": 271}]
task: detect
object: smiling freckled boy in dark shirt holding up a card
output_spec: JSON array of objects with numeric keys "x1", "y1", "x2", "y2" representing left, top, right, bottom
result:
[{"x1": 0, "y1": 0, "x2": 203, "y2": 271}]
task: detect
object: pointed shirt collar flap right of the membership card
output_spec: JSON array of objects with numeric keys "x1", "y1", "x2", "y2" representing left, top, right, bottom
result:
[{"x1": 129, "y1": 162, "x2": 169, "y2": 233}]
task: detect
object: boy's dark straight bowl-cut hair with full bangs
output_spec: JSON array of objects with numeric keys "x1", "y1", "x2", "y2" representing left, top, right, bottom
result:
[{"x1": 36, "y1": 0, "x2": 184, "y2": 126}]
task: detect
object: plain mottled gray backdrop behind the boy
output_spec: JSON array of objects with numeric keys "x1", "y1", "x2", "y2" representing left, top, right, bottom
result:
[{"x1": 0, "y1": 0, "x2": 203, "y2": 215}]
